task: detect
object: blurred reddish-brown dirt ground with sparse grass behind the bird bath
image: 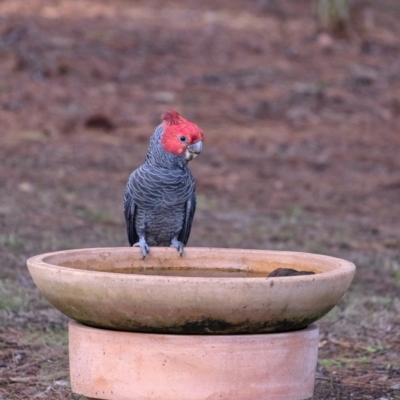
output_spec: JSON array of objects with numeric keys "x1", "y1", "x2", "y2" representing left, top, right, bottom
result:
[{"x1": 0, "y1": 0, "x2": 400, "y2": 400}]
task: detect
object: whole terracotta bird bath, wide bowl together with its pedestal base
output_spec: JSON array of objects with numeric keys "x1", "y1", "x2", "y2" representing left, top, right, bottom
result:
[{"x1": 27, "y1": 247, "x2": 355, "y2": 400}]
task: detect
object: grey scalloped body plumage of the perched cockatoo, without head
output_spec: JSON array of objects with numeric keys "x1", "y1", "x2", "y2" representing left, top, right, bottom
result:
[{"x1": 124, "y1": 125, "x2": 196, "y2": 250}]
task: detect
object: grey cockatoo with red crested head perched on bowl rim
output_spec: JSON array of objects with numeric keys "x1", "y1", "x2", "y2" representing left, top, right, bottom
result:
[{"x1": 124, "y1": 110, "x2": 204, "y2": 259}]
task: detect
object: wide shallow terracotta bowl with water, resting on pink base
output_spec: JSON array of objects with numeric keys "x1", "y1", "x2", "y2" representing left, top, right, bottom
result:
[{"x1": 28, "y1": 247, "x2": 355, "y2": 334}]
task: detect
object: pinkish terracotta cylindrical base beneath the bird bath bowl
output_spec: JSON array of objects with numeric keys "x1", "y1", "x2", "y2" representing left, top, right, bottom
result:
[{"x1": 69, "y1": 321, "x2": 318, "y2": 400}]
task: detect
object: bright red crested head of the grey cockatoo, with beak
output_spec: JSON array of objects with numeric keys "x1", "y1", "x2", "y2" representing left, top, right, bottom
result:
[{"x1": 161, "y1": 110, "x2": 204, "y2": 160}]
